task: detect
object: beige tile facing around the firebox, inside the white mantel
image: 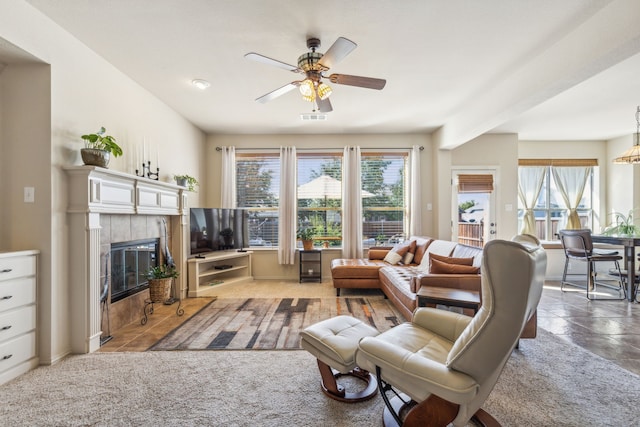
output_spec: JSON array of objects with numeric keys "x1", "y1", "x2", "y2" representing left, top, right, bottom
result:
[{"x1": 100, "y1": 215, "x2": 171, "y2": 334}]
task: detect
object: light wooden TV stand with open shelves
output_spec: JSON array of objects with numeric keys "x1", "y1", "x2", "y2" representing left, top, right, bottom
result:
[{"x1": 188, "y1": 251, "x2": 253, "y2": 298}]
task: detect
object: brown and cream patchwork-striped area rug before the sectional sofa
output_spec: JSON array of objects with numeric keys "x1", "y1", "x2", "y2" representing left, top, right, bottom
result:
[{"x1": 149, "y1": 297, "x2": 405, "y2": 350}]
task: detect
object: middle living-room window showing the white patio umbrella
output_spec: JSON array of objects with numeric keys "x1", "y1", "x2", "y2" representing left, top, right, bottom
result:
[{"x1": 298, "y1": 153, "x2": 342, "y2": 247}]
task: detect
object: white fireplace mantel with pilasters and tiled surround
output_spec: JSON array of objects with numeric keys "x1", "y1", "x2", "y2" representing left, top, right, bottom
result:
[{"x1": 65, "y1": 166, "x2": 187, "y2": 353}]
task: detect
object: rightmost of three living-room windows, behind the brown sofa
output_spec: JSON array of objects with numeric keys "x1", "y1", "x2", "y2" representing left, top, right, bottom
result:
[{"x1": 361, "y1": 152, "x2": 408, "y2": 246}]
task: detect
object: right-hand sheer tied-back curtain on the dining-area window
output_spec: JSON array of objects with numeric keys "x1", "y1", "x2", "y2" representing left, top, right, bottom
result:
[{"x1": 551, "y1": 166, "x2": 592, "y2": 230}]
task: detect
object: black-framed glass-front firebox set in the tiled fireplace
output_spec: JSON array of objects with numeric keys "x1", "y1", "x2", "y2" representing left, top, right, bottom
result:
[{"x1": 111, "y1": 239, "x2": 160, "y2": 303}]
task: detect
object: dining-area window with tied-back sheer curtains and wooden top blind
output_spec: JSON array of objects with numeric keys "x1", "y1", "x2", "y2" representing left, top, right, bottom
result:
[{"x1": 518, "y1": 159, "x2": 598, "y2": 240}]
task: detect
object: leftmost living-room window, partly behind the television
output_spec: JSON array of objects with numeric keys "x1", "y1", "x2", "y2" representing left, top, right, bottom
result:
[{"x1": 236, "y1": 153, "x2": 280, "y2": 247}]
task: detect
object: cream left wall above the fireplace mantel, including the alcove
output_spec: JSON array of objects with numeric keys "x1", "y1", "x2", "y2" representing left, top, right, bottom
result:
[{"x1": 0, "y1": 0, "x2": 206, "y2": 363}]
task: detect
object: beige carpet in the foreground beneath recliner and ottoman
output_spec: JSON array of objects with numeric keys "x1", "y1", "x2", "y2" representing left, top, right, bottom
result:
[{"x1": 0, "y1": 330, "x2": 640, "y2": 427}]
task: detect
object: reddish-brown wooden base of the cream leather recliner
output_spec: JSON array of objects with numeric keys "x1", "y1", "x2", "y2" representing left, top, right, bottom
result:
[{"x1": 382, "y1": 394, "x2": 501, "y2": 427}]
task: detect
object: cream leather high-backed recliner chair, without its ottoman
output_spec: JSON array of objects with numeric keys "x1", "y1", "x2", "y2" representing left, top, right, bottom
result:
[{"x1": 356, "y1": 238, "x2": 547, "y2": 427}]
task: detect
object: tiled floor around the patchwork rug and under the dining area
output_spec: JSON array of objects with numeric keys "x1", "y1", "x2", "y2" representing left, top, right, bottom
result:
[{"x1": 100, "y1": 280, "x2": 640, "y2": 374}]
